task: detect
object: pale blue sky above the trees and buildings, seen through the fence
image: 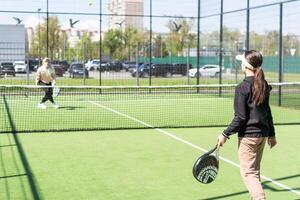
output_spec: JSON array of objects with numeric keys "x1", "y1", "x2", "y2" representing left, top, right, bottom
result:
[{"x1": 0, "y1": 0, "x2": 300, "y2": 35}]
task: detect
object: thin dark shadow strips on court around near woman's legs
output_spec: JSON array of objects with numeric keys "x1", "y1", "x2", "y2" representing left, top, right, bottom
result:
[{"x1": 199, "y1": 174, "x2": 300, "y2": 200}]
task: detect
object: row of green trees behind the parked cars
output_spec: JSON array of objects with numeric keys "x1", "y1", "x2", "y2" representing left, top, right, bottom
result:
[{"x1": 28, "y1": 16, "x2": 300, "y2": 61}]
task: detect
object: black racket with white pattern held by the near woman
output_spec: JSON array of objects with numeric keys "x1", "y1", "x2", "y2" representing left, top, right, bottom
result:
[{"x1": 193, "y1": 146, "x2": 219, "y2": 184}]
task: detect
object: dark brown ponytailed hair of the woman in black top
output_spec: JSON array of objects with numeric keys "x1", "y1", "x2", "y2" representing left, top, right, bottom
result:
[{"x1": 245, "y1": 50, "x2": 270, "y2": 106}]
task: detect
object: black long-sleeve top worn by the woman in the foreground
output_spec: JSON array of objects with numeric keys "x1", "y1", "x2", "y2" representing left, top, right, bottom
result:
[{"x1": 224, "y1": 76, "x2": 275, "y2": 137}]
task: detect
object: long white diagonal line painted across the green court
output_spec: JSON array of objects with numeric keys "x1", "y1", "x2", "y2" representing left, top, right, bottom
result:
[{"x1": 88, "y1": 101, "x2": 300, "y2": 196}]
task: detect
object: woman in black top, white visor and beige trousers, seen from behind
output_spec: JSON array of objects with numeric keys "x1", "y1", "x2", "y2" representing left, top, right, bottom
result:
[{"x1": 218, "y1": 50, "x2": 277, "y2": 200}]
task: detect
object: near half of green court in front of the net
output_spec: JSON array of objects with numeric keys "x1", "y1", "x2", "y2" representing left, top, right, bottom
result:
[{"x1": 0, "y1": 125, "x2": 300, "y2": 200}]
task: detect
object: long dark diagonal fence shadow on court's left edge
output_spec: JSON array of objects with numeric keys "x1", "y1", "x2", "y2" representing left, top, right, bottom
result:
[{"x1": 0, "y1": 96, "x2": 42, "y2": 200}]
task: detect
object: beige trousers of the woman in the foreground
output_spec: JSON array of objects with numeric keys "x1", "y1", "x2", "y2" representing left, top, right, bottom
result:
[{"x1": 238, "y1": 137, "x2": 267, "y2": 200}]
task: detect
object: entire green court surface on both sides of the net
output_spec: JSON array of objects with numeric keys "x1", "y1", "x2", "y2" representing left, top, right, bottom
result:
[{"x1": 0, "y1": 85, "x2": 300, "y2": 200}]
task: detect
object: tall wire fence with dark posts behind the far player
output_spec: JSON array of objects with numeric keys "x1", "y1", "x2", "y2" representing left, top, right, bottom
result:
[{"x1": 0, "y1": 0, "x2": 300, "y2": 86}]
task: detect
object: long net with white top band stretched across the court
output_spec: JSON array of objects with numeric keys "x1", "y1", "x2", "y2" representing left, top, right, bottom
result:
[{"x1": 0, "y1": 82, "x2": 300, "y2": 133}]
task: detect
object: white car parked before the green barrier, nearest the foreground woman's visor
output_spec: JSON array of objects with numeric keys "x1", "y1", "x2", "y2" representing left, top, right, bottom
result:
[{"x1": 189, "y1": 65, "x2": 224, "y2": 78}]
